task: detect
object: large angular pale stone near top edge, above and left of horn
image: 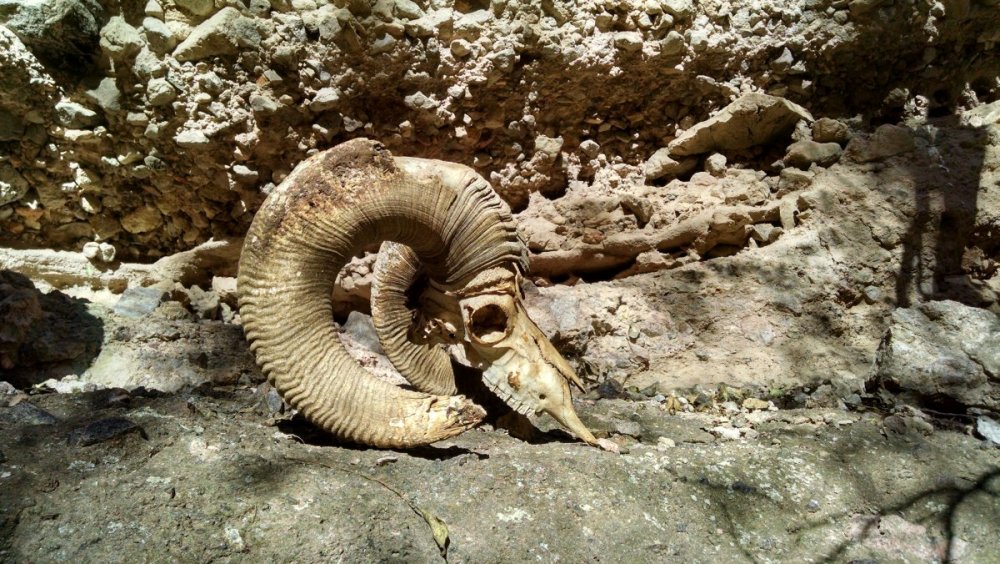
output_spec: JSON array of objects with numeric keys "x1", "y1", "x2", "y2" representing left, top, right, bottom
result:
[{"x1": 174, "y1": 6, "x2": 260, "y2": 62}]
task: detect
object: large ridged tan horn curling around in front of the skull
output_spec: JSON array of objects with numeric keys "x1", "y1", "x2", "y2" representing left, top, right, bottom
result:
[{"x1": 239, "y1": 139, "x2": 526, "y2": 447}]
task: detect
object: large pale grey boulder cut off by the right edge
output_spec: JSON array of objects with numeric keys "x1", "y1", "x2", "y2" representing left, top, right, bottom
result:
[{"x1": 873, "y1": 301, "x2": 1000, "y2": 409}]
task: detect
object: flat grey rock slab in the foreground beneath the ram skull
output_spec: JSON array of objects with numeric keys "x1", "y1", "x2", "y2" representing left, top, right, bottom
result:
[{"x1": 0, "y1": 385, "x2": 1000, "y2": 562}]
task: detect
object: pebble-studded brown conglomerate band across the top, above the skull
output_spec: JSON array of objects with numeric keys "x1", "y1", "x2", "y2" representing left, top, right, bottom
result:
[{"x1": 0, "y1": 0, "x2": 1000, "y2": 261}]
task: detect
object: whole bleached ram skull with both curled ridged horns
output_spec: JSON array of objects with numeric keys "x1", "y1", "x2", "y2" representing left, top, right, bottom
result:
[{"x1": 239, "y1": 139, "x2": 599, "y2": 448}]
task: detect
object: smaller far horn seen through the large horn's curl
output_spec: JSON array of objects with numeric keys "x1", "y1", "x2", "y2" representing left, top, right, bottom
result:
[{"x1": 372, "y1": 242, "x2": 457, "y2": 395}]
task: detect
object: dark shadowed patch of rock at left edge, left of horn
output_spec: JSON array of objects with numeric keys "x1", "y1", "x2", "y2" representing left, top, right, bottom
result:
[{"x1": 0, "y1": 270, "x2": 104, "y2": 388}]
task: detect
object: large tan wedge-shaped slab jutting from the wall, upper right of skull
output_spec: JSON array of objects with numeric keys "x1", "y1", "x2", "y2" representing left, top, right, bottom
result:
[{"x1": 668, "y1": 92, "x2": 813, "y2": 159}]
